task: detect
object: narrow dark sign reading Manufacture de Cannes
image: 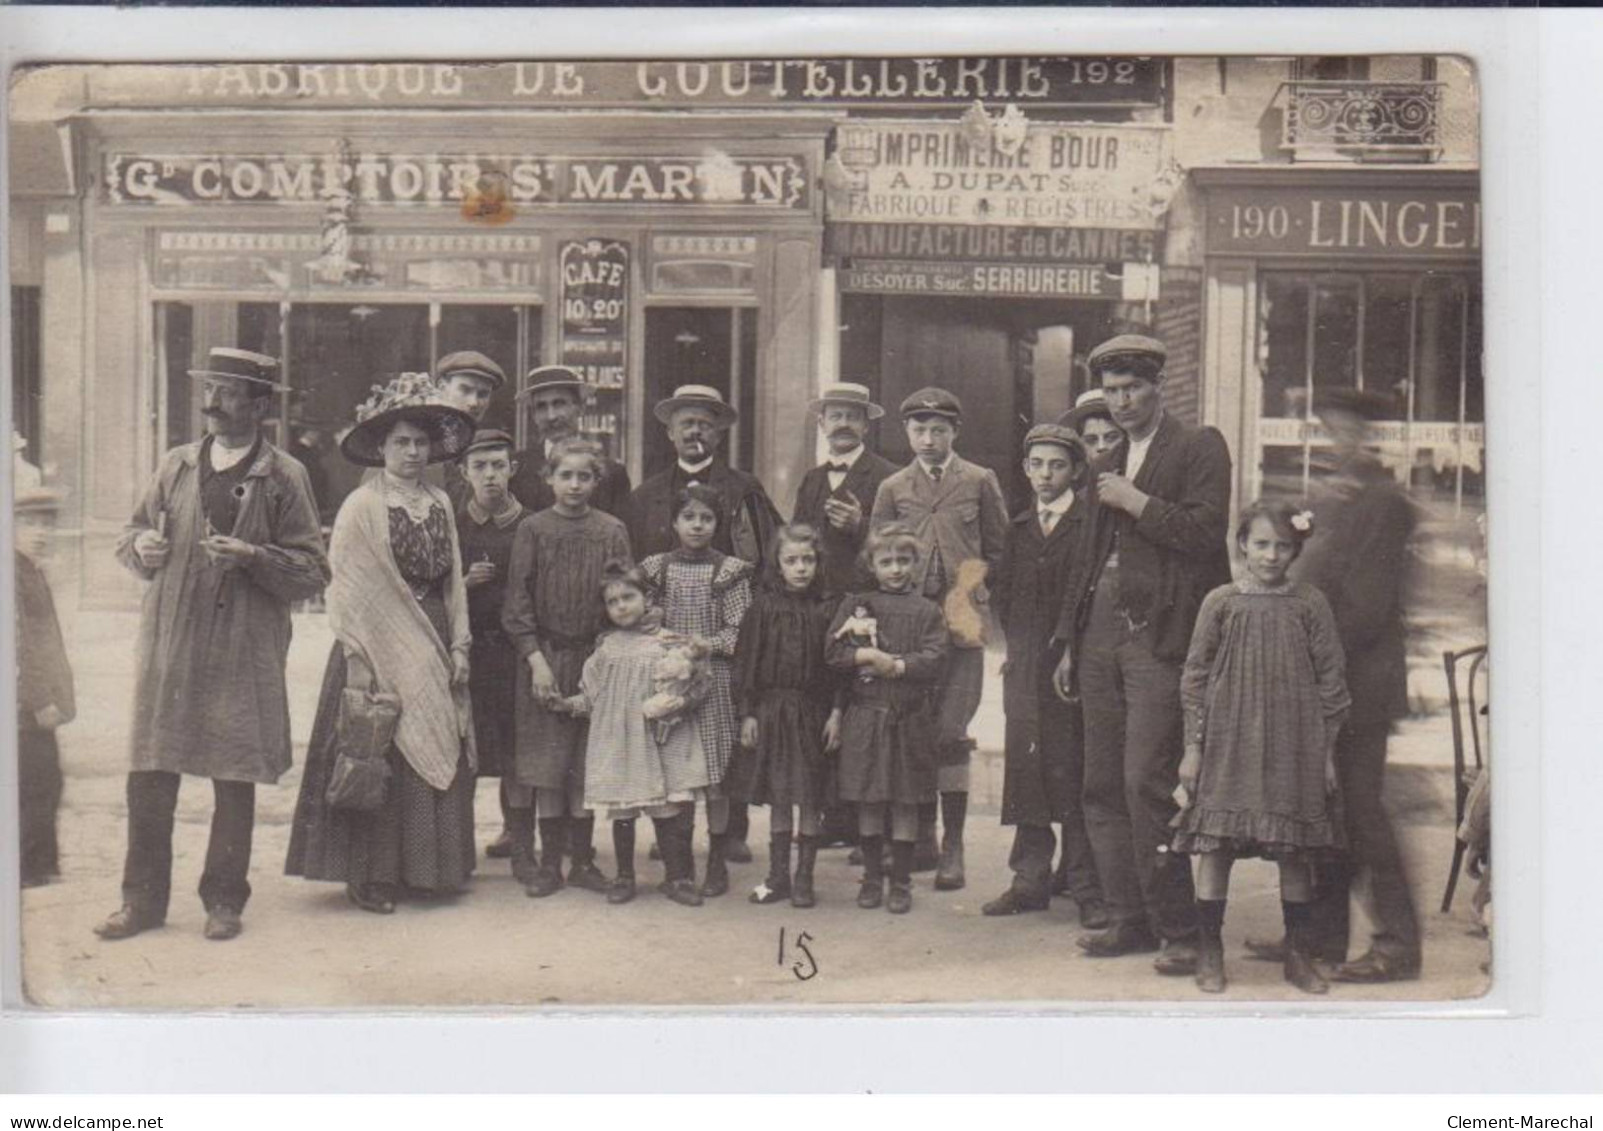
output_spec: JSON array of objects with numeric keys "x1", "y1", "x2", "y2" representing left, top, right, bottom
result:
[{"x1": 824, "y1": 223, "x2": 1164, "y2": 263}]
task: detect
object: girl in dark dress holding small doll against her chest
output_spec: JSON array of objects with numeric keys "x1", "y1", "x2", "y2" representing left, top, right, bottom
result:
[{"x1": 826, "y1": 522, "x2": 947, "y2": 915}]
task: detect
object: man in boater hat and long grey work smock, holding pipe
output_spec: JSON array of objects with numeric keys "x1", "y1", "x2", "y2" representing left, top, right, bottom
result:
[{"x1": 95, "y1": 348, "x2": 329, "y2": 940}]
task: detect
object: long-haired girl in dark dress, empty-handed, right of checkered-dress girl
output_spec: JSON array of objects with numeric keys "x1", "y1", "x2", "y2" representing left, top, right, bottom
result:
[{"x1": 734, "y1": 524, "x2": 840, "y2": 907}]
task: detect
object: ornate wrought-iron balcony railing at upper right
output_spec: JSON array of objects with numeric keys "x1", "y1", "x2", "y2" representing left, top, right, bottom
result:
[{"x1": 1281, "y1": 80, "x2": 1443, "y2": 160}]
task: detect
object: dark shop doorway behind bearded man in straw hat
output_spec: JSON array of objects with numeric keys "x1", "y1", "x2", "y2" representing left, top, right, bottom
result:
[{"x1": 643, "y1": 306, "x2": 757, "y2": 476}]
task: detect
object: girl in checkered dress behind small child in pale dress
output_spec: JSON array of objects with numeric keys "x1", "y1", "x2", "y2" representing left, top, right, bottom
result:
[{"x1": 641, "y1": 485, "x2": 752, "y2": 899}]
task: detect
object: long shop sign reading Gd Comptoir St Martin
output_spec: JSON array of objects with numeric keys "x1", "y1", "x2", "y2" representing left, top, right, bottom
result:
[{"x1": 101, "y1": 152, "x2": 811, "y2": 209}]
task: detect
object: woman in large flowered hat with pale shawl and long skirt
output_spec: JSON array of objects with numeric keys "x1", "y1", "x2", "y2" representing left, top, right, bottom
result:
[{"x1": 285, "y1": 375, "x2": 476, "y2": 915}]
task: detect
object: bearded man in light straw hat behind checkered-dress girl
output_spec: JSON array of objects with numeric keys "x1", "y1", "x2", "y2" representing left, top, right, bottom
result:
[{"x1": 627, "y1": 384, "x2": 784, "y2": 566}]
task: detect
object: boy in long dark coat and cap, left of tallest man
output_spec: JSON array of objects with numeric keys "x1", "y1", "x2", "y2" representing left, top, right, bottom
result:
[{"x1": 981, "y1": 425, "x2": 1108, "y2": 929}]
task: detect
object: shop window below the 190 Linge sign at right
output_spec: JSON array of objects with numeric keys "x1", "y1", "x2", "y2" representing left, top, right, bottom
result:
[{"x1": 1258, "y1": 271, "x2": 1484, "y2": 506}]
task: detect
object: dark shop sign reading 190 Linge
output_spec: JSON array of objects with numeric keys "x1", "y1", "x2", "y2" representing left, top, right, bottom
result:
[{"x1": 1207, "y1": 186, "x2": 1481, "y2": 260}]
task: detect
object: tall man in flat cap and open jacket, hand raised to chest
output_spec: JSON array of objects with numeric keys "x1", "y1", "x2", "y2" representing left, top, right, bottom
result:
[{"x1": 1053, "y1": 333, "x2": 1231, "y2": 974}]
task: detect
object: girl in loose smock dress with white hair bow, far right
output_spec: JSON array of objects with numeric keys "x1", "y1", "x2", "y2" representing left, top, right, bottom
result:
[{"x1": 1173, "y1": 501, "x2": 1350, "y2": 993}]
